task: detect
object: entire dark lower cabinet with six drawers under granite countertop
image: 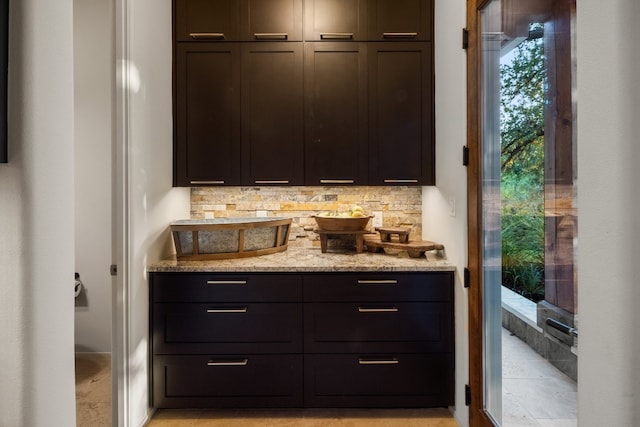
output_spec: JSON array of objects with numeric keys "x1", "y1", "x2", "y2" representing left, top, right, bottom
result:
[{"x1": 150, "y1": 272, "x2": 454, "y2": 408}]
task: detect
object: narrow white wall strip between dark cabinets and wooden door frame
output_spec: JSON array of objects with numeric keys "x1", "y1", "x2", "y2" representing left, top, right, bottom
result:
[{"x1": 422, "y1": 0, "x2": 469, "y2": 426}]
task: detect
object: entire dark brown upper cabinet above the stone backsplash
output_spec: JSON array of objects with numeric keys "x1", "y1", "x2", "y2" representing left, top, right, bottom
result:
[{"x1": 173, "y1": 0, "x2": 435, "y2": 186}]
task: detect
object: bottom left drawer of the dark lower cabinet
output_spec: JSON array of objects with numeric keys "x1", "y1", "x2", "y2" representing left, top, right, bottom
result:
[{"x1": 153, "y1": 354, "x2": 302, "y2": 408}]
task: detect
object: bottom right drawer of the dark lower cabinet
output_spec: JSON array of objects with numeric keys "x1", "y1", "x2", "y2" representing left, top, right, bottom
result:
[{"x1": 304, "y1": 354, "x2": 453, "y2": 407}]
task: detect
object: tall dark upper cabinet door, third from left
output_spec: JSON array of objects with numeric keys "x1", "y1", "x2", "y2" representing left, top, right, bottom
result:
[{"x1": 305, "y1": 42, "x2": 368, "y2": 185}]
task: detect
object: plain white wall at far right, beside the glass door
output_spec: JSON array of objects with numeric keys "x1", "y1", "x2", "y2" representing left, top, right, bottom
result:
[{"x1": 577, "y1": 0, "x2": 640, "y2": 427}]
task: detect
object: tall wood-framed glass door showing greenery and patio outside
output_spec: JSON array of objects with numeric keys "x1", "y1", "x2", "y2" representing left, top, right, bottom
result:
[{"x1": 469, "y1": 0, "x2": 578, "y2": 427}]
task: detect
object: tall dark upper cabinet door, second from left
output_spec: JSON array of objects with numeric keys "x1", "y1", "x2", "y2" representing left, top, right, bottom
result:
[{"x1": 242, "y1": 42, "x2": 304, "y2": 185}]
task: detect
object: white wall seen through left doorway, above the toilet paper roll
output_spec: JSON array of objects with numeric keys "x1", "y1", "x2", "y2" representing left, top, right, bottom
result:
[{"x1": 73, "y1": 0, "x2": 115, "y2": 353}]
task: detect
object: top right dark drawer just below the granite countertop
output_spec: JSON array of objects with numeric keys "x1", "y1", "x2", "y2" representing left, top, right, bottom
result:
[{"x1": 303, "y1": 272, "x2": 453, "y2": 302}]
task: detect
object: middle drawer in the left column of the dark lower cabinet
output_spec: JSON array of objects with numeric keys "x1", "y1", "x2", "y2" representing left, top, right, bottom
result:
[{"x1": 153, "y1": 303, "x2": 302, "y2": 354}]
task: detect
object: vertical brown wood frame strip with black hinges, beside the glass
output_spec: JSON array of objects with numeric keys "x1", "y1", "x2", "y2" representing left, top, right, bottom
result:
[{"x1": 467, "y1": 0, "x2": 494, "y2": 427}]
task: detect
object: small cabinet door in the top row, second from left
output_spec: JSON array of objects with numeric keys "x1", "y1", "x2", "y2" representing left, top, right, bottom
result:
[{"x1": 240, "y1": 0, "x2": 302, "y2": 41}]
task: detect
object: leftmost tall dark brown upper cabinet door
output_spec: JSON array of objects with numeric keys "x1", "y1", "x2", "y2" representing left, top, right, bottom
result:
[{"x1": 174, "y1": 43, "x2": 240, "y2": 186}]
